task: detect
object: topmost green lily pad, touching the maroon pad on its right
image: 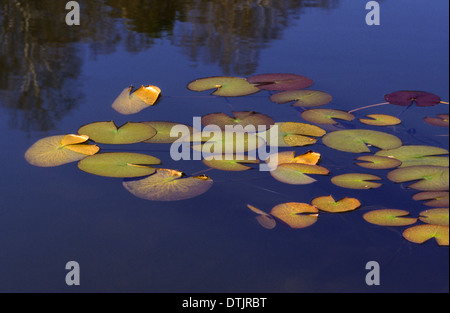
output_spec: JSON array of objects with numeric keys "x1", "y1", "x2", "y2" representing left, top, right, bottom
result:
[{"x1": 188, "y1": 76, "x2": 260, "y2": 97}]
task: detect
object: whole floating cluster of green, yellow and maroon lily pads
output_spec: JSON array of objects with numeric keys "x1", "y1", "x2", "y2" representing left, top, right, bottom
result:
[{"x1": 25, "y1": 73, "x2": 449, "y2": 245}]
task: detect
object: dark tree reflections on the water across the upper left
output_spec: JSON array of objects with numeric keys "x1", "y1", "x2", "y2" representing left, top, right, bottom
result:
[{"x1": 0, "y1": 0, "x2": 338, "y2": 131}]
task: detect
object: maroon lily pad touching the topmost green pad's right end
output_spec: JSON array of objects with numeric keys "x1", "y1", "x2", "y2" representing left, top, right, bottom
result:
[{"x1": 248, "y1": 74, "x2": 314, "y2": 91}]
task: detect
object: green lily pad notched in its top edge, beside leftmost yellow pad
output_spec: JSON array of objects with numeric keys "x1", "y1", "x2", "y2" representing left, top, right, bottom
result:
[{"x1": 78, "y1": 122, "x2": 156, "y2": 145}]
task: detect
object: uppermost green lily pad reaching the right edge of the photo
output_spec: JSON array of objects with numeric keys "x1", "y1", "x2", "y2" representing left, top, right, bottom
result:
[{"x1": 375, "y1": 146, "x2": 449, "y2": 167}]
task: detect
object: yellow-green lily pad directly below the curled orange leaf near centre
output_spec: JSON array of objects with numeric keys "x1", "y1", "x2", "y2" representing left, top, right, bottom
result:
[{"x1": 270, "y1": 163, "x2": 330, "y2": 185}]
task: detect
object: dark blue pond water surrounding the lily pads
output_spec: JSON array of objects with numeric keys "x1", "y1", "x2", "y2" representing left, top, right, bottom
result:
[{"x1": 0, "y1": 0, "x2": 449, "y2": 292}]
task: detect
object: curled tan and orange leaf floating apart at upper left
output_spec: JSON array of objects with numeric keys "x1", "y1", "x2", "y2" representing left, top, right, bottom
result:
[{"x1": 112, "y1": 85, "x2": 161, "y2": 115}]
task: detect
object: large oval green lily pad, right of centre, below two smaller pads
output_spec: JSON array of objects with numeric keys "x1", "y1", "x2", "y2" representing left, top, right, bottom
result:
[{"x1": 322, "y1": 129, "x2": 402, "y2": 156}]
